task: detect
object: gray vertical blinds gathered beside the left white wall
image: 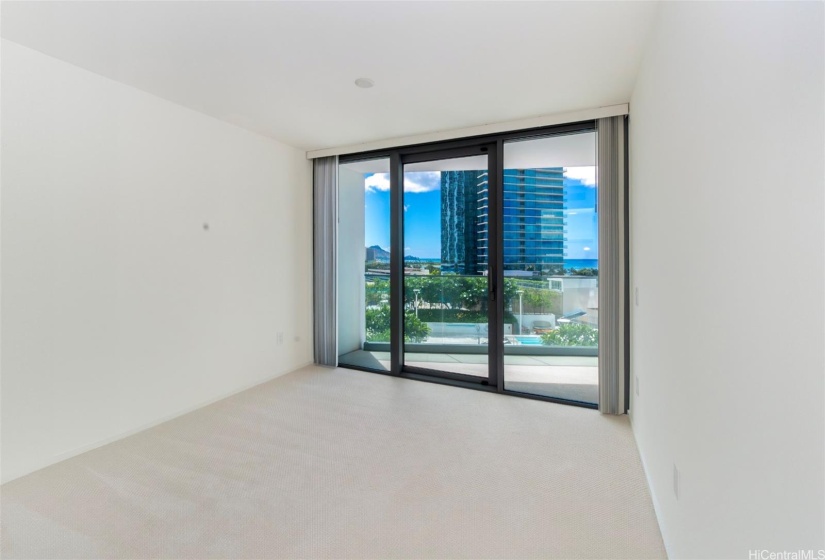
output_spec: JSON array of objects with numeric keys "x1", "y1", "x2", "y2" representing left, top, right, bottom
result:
[{"x1": 313, "y1": 156, "x2": 338, "y2": 366}]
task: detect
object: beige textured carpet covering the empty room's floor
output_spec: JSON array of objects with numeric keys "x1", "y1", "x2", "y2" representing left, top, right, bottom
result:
[{"x1": 0, "y1": 367, "x2": 665, "y2": 559}]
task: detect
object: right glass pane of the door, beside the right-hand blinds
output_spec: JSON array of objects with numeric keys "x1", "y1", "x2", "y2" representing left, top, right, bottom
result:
[{"x1": 502, "y1": 132, "x2": 599, "y2": 403}]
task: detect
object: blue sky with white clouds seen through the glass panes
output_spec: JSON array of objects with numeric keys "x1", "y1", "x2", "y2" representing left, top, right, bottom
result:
[{"x1": 364, "y1": 168, "x2": 598, "y2": 259}]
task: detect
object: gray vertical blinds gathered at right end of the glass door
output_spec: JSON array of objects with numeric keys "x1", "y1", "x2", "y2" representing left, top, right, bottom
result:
[{"x1": 596, "y1": 116, "x2": 627, "y2": 414}]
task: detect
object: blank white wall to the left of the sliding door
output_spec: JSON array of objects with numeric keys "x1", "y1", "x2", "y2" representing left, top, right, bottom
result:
[{"x1": 2, "y1": 41, "x2": 312, "y2": 481}]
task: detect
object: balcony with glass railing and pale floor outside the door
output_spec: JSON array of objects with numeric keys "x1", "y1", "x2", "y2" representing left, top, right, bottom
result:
[{"x1": 339, "y1": 274, "x2": 598, "y2": 403}]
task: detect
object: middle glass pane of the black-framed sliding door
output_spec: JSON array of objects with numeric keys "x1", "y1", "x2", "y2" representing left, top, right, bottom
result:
[{"x1": 403, "y1": 154, "x2": 490, "y2": 380}]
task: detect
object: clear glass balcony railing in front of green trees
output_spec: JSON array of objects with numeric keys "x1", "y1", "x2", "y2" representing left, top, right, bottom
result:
[{"x1": 364, "y1": 272, "x2": 599, "y2": 350}]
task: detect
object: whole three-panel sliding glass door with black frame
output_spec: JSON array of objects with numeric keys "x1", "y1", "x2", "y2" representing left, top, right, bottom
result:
[{"x1": 339, "y1": 122, "x2": 612, "y2": 406}]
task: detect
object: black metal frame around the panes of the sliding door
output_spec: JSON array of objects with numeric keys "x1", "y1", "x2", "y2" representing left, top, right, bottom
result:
[{"x1": 338, "y1": 120, "x2": 598, "y2": 409}]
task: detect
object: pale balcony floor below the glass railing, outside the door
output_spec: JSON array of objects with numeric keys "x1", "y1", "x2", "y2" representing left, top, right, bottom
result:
[{"x1": 338, "y1": 350, "x2": 599, "y2": 404}]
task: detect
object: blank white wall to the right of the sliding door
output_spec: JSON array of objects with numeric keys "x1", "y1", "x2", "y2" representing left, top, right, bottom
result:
[{"x1": 630, "y1": 2, "x2": 825, "y2": 558}]
